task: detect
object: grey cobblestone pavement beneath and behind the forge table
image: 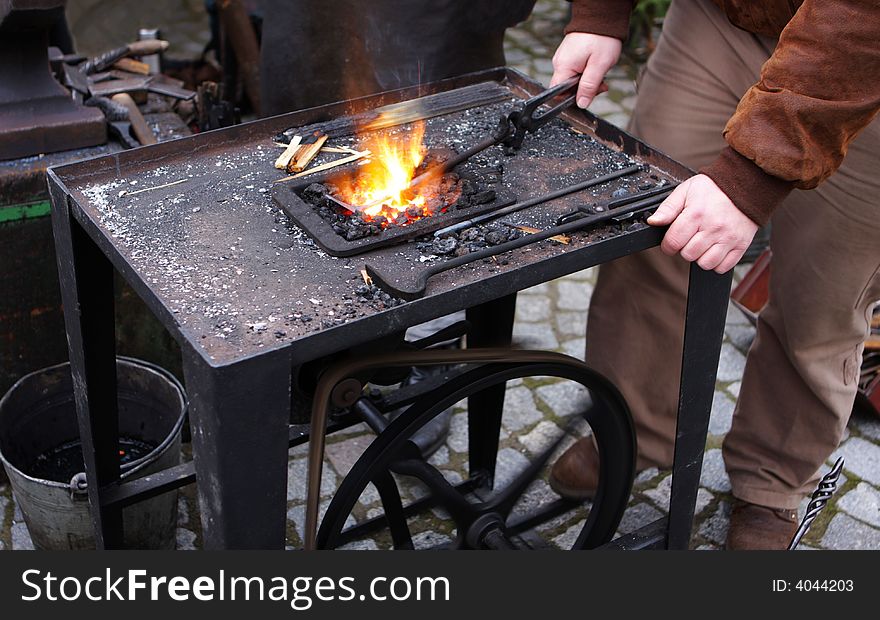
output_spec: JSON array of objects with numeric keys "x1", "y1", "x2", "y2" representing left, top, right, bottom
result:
[{"x1": 0, "y1": 0, "x2": 880, "y2": 549}]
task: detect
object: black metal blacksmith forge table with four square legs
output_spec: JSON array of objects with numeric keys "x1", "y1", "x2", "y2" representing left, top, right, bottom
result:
[{"x1": 49, "y1": 69, "x2": 730, "y2": 549}]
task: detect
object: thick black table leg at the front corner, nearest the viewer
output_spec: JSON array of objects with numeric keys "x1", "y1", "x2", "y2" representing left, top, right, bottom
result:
[{"x1": 184, "y1": 350, "x2": 291, "y2": 549}]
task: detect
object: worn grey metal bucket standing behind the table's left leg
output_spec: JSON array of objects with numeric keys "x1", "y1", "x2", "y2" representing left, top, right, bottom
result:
[{"x1": 0, "y1": 357, "x2": 186, "y2": 550}]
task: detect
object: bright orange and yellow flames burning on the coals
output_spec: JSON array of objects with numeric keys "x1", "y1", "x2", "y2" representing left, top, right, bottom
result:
[{"x1": 336, "y1": 122, "x2": 454, "y2": 227}]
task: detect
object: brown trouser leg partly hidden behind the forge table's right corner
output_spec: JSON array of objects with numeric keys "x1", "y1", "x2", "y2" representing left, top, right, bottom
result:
[{"x1": 587, "y1": 0, "x2": 773, "y2": 468}]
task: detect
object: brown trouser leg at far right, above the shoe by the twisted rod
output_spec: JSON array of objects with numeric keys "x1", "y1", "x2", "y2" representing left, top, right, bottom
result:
[{"x1": 723, "y1": 121, "x2": 880, "y2": 508}]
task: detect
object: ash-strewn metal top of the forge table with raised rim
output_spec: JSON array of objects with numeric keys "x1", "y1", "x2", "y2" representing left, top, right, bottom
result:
[{"x1": 50, "y1": 68, "x2": 690, "y2": 366}]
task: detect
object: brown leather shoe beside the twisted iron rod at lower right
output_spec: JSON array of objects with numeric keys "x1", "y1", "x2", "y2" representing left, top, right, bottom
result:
[{"x1": 726, "y1": 500, "x2": 798, "y2": 551}]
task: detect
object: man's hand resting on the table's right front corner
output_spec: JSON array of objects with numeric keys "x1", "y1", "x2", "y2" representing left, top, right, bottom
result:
[{"x1": 648, "y1": 174, "x2": 758, "y2": 273}]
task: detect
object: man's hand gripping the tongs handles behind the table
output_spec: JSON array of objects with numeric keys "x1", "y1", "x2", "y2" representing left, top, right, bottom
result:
[{"x1": 550, "y1": 32, "x2": 623, "y2": 109}]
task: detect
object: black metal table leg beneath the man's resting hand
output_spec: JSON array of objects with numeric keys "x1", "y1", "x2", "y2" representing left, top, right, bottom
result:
[{"x1": 666, "y1": 263, "x2": 733, "y2": 549}]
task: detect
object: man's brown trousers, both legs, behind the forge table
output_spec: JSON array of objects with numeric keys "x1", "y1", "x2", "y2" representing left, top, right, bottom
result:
[{"x1": 587, "y1": 0, "x2": 880, "y2": 508}]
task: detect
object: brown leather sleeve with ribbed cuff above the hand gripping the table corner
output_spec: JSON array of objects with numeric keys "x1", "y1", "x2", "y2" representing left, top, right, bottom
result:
[{"x1": 705, "y1": 0, "x2": 880, "y2": 222}]
